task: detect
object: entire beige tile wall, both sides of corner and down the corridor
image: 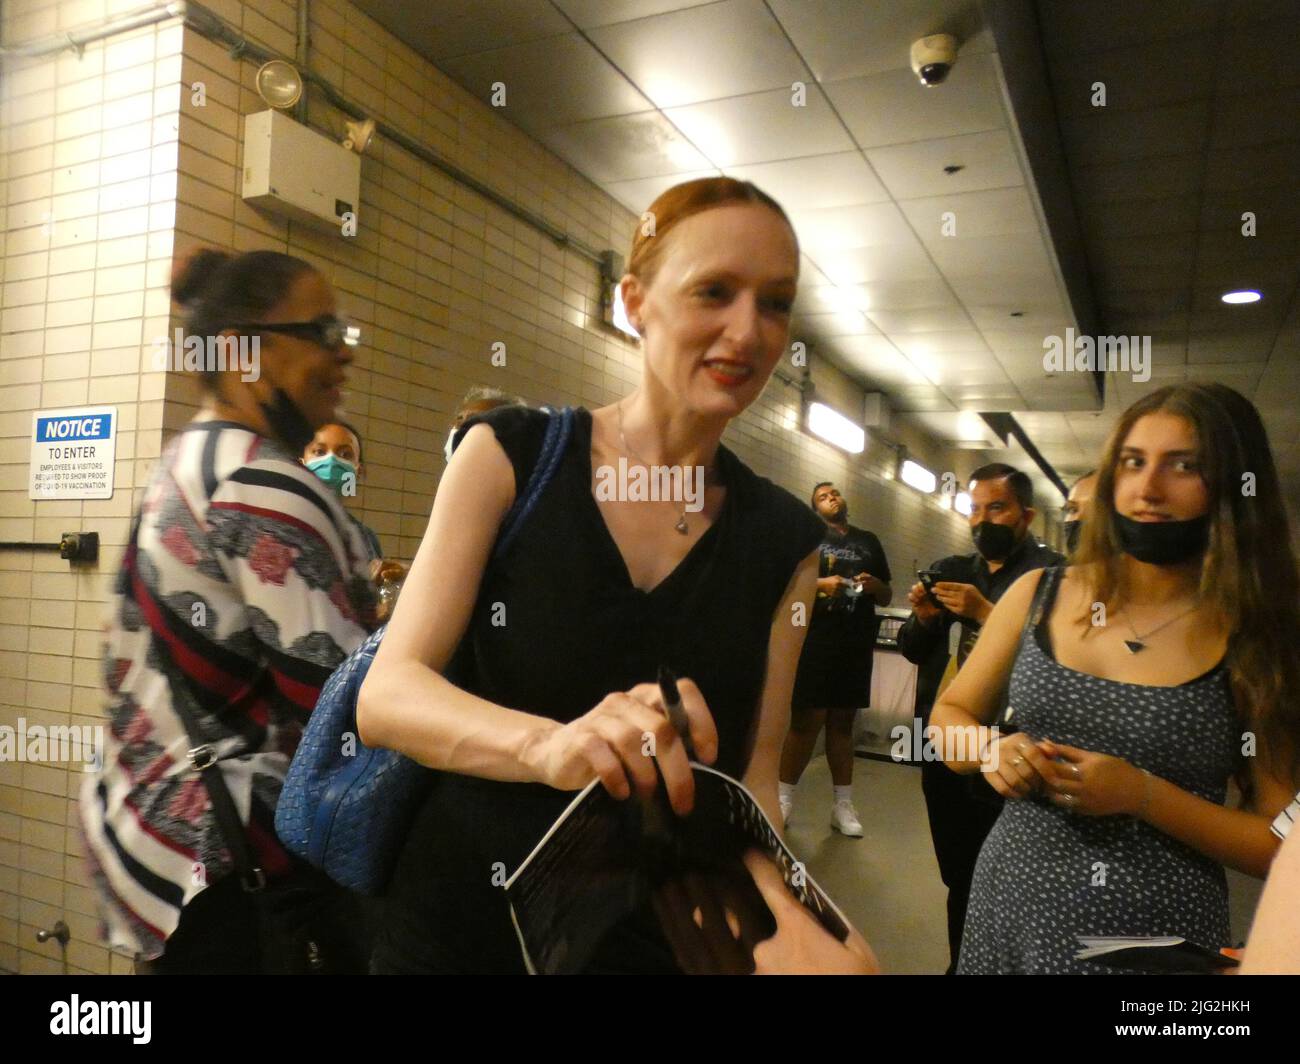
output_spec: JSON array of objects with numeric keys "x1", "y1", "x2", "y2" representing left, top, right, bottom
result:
[{"x1": 0, "y1": 0, "x2": 974, "y2": 972}]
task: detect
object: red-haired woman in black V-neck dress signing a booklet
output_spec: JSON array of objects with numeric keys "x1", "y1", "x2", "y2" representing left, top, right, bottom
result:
[{"x1": 358, "y1": 177, "x2": 823, "y2": 973}]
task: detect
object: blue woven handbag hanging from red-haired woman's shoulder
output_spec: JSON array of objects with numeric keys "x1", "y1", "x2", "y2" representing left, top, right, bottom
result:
[{"x1": 276, "y1": 407, "x2": 573, "y2": 894}]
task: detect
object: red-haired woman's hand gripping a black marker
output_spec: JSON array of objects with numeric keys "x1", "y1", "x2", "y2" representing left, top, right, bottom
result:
[{"x1": 521, "y1": 678, "x2": 718, "y2": 816}]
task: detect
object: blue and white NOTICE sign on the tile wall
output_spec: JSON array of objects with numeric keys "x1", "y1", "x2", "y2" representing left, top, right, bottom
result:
[{"x1": 27, "y1": 406, "x2": 117, "y2": 498}]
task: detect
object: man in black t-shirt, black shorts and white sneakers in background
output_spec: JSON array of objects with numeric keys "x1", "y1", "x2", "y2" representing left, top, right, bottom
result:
[{"x1": 780, "y1": 481, "x2": 892, "y2": 838}]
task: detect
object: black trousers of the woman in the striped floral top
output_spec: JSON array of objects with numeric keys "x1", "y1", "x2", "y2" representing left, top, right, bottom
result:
[{"x1": 135, "y1": 869, "x2": 377, "y2": 976}]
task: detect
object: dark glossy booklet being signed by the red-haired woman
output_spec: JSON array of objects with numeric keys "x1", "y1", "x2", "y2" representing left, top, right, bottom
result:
[{"x1": 506, "y1": 761, "x2": 849, "y2": 974}]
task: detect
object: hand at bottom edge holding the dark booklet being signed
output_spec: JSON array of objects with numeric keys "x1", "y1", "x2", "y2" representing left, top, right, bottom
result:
[{"x1": 745, "y1": 849, "x2": 880, "y2": 976}]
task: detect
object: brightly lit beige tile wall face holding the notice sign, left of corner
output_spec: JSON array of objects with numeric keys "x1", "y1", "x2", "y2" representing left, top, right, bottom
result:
[{"x1": 0, "y1": 0, "x2": 182, "y2": 972}]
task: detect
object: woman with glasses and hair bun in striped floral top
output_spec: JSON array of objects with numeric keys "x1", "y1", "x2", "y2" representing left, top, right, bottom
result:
[{"x1": 81, "y1": 248, "x2": 374, "y2": 973}]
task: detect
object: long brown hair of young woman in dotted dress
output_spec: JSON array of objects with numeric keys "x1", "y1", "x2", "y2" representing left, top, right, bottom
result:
[{"x1": 1076, "y1": 384, "x2": 1300, "y2": 786}]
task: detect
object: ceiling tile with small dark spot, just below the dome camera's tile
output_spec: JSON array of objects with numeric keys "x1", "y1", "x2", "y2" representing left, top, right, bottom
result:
[{"x1": 866, "y1": 130, "x2": 1024, "y2": 199}]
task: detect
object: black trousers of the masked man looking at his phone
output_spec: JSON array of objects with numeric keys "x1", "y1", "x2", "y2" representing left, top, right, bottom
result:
[{"x1": 920, "y1": 761, "x2": 1002, "y2": 976}]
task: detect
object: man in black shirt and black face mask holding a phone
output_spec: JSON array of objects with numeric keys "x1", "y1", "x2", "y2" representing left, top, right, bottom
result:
[{"x1": 898, "y1": 463, "x2": 1063, "y2": 974}]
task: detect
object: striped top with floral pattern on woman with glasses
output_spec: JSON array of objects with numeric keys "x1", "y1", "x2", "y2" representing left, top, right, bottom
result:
[{"x1": 81, "y1": 421, "x2": 376, "y2": 960}]
